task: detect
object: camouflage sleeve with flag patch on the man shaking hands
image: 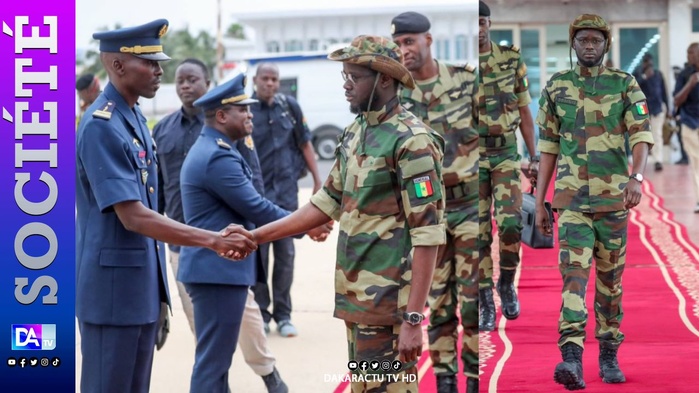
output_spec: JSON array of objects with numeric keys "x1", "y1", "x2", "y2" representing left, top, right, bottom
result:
[{"x1": 396, "y1": 134, "x2": 446, "y2": 246}]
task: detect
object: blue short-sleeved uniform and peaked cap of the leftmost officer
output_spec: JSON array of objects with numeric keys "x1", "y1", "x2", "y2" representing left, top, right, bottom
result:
[{"x1": 75, "y1": 19, "x2": 169, "y2": 392}]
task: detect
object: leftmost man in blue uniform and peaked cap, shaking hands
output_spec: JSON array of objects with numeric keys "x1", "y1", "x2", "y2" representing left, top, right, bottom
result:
[{"x1": 75, "y1": 19, "x2": 257, "y2": 393}]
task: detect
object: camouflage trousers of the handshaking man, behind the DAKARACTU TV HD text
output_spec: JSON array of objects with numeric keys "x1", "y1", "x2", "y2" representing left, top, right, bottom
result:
[{"x1": 345, "y1": 322, "x2": 418, "y2": 393}]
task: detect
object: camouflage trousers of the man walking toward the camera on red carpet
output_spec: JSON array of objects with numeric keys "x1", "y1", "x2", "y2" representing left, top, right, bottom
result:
[{"x1": 558, "y1": 209, "x2": 628, "y2": 347}]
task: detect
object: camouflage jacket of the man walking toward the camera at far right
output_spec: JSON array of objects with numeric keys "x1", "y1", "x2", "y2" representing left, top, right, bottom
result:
[{"x1": 536, "y1": 65, "x2": 653, "y2": 213}]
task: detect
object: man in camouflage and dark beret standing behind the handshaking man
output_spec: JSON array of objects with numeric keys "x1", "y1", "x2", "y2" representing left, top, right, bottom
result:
[{"x1": 391, "y1": 12, "x2": 478, "y2": 393}]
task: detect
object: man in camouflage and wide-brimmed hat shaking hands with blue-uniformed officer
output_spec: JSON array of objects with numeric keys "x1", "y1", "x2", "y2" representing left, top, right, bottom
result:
[{"x1": 253, "y1": 36, "x2": 446, "y2": 393}]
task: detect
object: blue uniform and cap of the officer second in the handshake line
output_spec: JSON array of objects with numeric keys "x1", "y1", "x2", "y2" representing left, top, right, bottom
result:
[{"x1": 177, "y1": 75, "x2": 289, "y2": 393}]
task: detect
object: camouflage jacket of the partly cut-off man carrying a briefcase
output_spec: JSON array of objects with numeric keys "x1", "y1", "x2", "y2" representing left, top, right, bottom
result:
[{"x1": 478, "y1": 41, "x2": 532, "y2": 136}]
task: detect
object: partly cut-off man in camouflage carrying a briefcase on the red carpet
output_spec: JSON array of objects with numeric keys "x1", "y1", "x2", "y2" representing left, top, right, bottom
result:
[{"x1": 478, "y1": 1, "x2": 539, "y2": 331}]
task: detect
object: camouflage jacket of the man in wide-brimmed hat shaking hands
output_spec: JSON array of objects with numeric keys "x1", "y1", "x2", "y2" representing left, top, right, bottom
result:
[{"x1": 311, "y1": 99, "x2": 446, "y2": 325}]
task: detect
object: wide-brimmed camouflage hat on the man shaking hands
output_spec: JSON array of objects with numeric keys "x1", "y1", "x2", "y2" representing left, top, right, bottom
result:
[{"x1": 328, "y1": 35, "x2": 415, "y2": 89}]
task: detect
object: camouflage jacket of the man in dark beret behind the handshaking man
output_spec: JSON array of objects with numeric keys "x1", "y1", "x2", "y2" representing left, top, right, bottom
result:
[{"x1": 398, "y1": 62, "x2": 478, "y2": 187}]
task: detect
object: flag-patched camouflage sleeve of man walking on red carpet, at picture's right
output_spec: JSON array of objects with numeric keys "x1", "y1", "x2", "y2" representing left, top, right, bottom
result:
[{"x1": 624, "y1": 76, "x2": 653, "y2": 150}]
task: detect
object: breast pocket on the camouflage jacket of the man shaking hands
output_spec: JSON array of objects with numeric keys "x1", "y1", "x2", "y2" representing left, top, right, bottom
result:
[{"x1": 357, "y1": 167, "x2": 400, "y2": 216}]
